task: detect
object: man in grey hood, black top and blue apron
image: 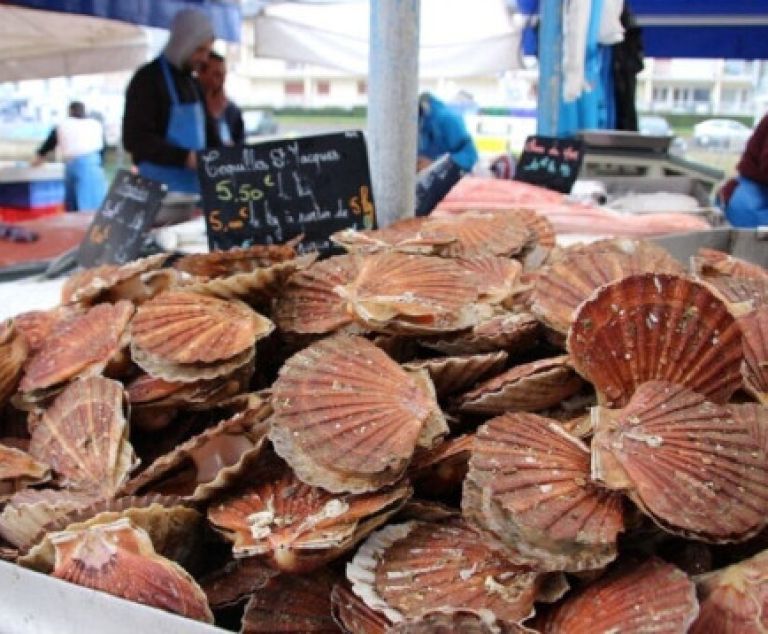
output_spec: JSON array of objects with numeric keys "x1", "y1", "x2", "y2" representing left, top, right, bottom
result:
[{"x1": 123, "y1": 9, "x2": 218, "y2": 194}]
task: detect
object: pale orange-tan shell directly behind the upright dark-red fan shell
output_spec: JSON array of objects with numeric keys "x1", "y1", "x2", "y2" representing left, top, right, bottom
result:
[{"x1": 531, "y1": 241, "x2": 684, "y2": 334}]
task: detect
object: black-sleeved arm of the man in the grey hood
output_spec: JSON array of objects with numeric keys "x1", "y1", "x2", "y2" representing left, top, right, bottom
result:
[{"x1": 123, "y1": 66, "x2": 190, "y2": 167}]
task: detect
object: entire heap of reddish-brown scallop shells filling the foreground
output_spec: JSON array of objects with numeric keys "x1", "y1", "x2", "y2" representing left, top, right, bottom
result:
[{"x1": 0, "y1": 210, "x2": 768, "y2": 634}]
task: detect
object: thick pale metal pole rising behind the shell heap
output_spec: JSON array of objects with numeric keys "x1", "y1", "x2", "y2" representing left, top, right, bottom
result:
[{"x1": 368, "y1": 0, "x2": 420, "y2": 227}]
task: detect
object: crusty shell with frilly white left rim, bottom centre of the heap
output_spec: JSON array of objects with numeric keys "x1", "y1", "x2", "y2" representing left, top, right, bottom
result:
[{"x1": 347, "y1": 520, "x2": 545, "y2": 623}]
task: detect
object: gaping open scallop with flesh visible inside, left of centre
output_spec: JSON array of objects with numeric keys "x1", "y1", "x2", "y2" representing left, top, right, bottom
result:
[{"x1": 123, "y1": 405, "x2": 272, "y2": 501}]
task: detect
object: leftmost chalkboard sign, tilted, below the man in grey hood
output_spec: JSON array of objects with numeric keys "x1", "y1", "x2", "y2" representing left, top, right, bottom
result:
[{"x1": 77, "y1": 170, "x2": 166, "y2": 267}]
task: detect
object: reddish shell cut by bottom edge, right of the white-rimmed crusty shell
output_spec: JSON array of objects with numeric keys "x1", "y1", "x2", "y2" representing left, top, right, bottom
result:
[{"x1": 540, "y1": 559, "x2": 696, "y2": 634}]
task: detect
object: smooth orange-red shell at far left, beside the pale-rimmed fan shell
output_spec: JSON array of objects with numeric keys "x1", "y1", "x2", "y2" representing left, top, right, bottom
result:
[{"x1": 19, "y1": 301, "x2": 134, "y2": 392}]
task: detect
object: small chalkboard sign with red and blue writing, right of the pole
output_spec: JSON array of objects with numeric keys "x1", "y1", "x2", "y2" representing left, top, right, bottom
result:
[{"x1": 515, "y1": 136, "x2": 584, "y2": 194}]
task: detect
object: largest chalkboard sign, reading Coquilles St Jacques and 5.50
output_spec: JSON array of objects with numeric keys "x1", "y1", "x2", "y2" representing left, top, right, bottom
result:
[{"x1": 198, "y1": 131, "x2": 376, "y2": 255}]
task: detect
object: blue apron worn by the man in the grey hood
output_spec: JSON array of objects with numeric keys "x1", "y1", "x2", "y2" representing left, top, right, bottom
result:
[{"x1": 138, "y1": 56, "x2": 205, "y2": 194}]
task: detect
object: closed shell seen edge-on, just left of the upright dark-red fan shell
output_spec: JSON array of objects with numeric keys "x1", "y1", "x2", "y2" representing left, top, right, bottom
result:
[{"x1": 458, "y1": 355, "x2": 584, "y2": 414}]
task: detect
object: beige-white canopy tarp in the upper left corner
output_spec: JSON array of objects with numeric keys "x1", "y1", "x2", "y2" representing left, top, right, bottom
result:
[{"x1": 0, "y1": 4, "x2": 149, "y2": 81}]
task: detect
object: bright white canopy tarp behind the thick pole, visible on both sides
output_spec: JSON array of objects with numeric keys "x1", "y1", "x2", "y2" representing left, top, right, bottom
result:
[{"x1": 255, "y1": 0, "x2": 524, "y2": 78}]
